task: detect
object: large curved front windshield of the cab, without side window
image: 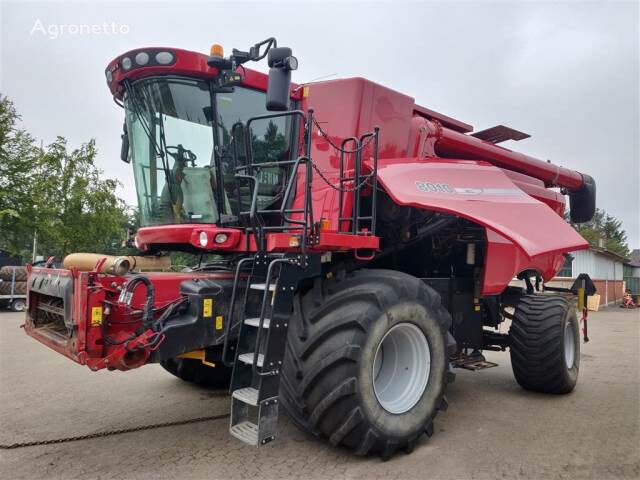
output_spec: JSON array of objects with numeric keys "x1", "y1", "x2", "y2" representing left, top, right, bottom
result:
[{"x1": 125, "y1": 78, "x2": 218, "y2": 226}]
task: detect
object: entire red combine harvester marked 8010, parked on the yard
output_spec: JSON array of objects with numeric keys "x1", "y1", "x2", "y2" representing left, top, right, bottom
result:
[{"x1": 25, "y1": 39, "x2": 595, "y2": 458}]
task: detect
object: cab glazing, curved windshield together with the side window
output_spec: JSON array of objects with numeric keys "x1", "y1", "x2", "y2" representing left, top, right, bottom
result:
[{"x1": 124, "y1": 77, "x2": 292, "y2": 226}]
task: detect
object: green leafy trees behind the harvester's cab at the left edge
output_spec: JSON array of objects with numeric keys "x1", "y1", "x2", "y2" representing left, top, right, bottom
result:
[{"x1": 0, "y1": 96, "x2": 132, "y2": 260}]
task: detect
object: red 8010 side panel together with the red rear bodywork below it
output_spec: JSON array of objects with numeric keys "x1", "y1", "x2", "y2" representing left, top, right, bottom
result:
[{"x1": 378, "y1": 158, "x2": 588, "y2": 295}]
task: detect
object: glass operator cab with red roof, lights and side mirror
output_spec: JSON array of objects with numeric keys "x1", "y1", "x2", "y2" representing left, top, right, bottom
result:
[{"x1": 106, "y1": 39, "x2": 300, "y2": 250}]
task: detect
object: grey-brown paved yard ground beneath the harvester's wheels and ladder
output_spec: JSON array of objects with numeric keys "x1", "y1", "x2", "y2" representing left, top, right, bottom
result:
[{"x1": 0, "y1": 308, "x2": 640, "y2": 479}]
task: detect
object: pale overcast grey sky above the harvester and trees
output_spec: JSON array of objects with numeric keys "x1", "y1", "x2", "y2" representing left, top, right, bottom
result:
[{"x1": 0, "y1": 0, "x2": 640, "y2": 248}]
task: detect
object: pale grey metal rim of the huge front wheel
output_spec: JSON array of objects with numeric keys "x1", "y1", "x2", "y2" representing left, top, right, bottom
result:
[{"x1": 373, "y1": 323, "x2": 431, "y2": 414}]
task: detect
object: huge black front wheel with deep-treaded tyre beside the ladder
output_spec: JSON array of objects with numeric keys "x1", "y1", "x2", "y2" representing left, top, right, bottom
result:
[{"x1": 280, "y1": 270, "x2": 453, "y2": 459}]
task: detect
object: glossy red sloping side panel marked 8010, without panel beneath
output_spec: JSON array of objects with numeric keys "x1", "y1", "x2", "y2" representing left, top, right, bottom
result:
[{"x1": 367, "y1": 158, "x2": 588, "y2": 258}]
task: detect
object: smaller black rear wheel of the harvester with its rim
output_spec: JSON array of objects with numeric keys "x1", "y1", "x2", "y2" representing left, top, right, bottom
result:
[{"x1": 509, "y1": 295, "x2": 580, "y2": 394}]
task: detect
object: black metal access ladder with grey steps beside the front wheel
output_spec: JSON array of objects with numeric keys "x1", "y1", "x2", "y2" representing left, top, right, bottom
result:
[{"x1": 223, "y1": 252, "x2": 320, "y2": 445}]
